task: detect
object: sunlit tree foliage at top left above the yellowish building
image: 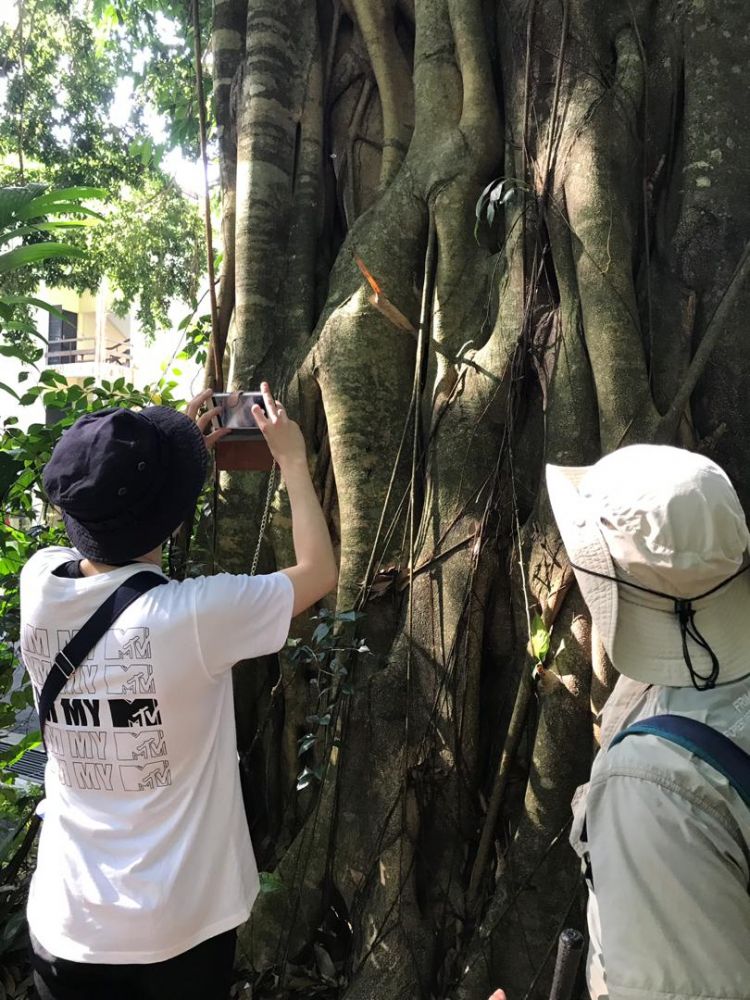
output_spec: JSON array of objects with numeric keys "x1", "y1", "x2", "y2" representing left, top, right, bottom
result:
[{"x1": 0, "y1": 0, "x2": 203, "y2": 334}]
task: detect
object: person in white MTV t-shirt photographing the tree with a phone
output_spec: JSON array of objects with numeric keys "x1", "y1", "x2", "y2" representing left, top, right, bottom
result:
[{"x1": 21, "y1": 383, "x2": 337, "y2": 1000}]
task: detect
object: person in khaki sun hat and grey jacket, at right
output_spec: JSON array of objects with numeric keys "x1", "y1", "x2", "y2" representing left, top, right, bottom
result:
[{"x1": 547, "y1": 445, "x2": 750, "y2": 1000}]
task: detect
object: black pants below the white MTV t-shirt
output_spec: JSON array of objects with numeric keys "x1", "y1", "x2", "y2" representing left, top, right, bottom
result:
[{"x1": 31, "y1": 930, "x2": 237, "y2": 1000}]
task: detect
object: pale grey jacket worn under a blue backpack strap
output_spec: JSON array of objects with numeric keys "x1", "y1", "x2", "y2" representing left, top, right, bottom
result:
[{"x1": 571, "y1": 674, "x2": 750, "y2": 1000}]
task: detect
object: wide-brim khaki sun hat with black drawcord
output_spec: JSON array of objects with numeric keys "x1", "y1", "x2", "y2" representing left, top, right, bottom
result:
[{"x1": 547, "y1": 445, "x2": 750, "y2": 687}]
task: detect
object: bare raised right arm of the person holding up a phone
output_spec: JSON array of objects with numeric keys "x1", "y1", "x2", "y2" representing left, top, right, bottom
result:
[{"x1": 253, "y1": 382, "x2": 338, "y2": 615}]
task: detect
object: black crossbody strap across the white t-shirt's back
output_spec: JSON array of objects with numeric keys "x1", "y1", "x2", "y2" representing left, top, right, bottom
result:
[{"x1": 39, "y1": 570, "x2": 169, "y2": 739}]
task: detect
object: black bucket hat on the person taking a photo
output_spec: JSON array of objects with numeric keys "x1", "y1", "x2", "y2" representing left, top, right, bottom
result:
[{"x1": 44, "y1": 406, "x2": 208, "y2": 565}]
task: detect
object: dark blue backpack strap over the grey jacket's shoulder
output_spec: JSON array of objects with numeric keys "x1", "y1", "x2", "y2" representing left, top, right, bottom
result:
[{"x1": 609, "y1": 715, "x2": 750, "y2": 808}]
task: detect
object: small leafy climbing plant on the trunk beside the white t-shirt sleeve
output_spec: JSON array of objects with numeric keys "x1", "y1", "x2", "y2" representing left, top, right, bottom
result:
[{"x1": 287, "y1": 608, "x2": 372, "y2": 792}]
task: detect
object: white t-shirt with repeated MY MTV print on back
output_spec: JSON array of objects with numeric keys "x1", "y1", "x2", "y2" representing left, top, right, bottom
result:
[{"x1": 21, "y1": 547, "x2": 294, "y2": 964}]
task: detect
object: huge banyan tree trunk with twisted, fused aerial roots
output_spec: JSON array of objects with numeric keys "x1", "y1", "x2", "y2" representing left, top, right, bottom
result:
[{"x1": 206, "y1": 0, "x2": 750, "y2": 1000}]
